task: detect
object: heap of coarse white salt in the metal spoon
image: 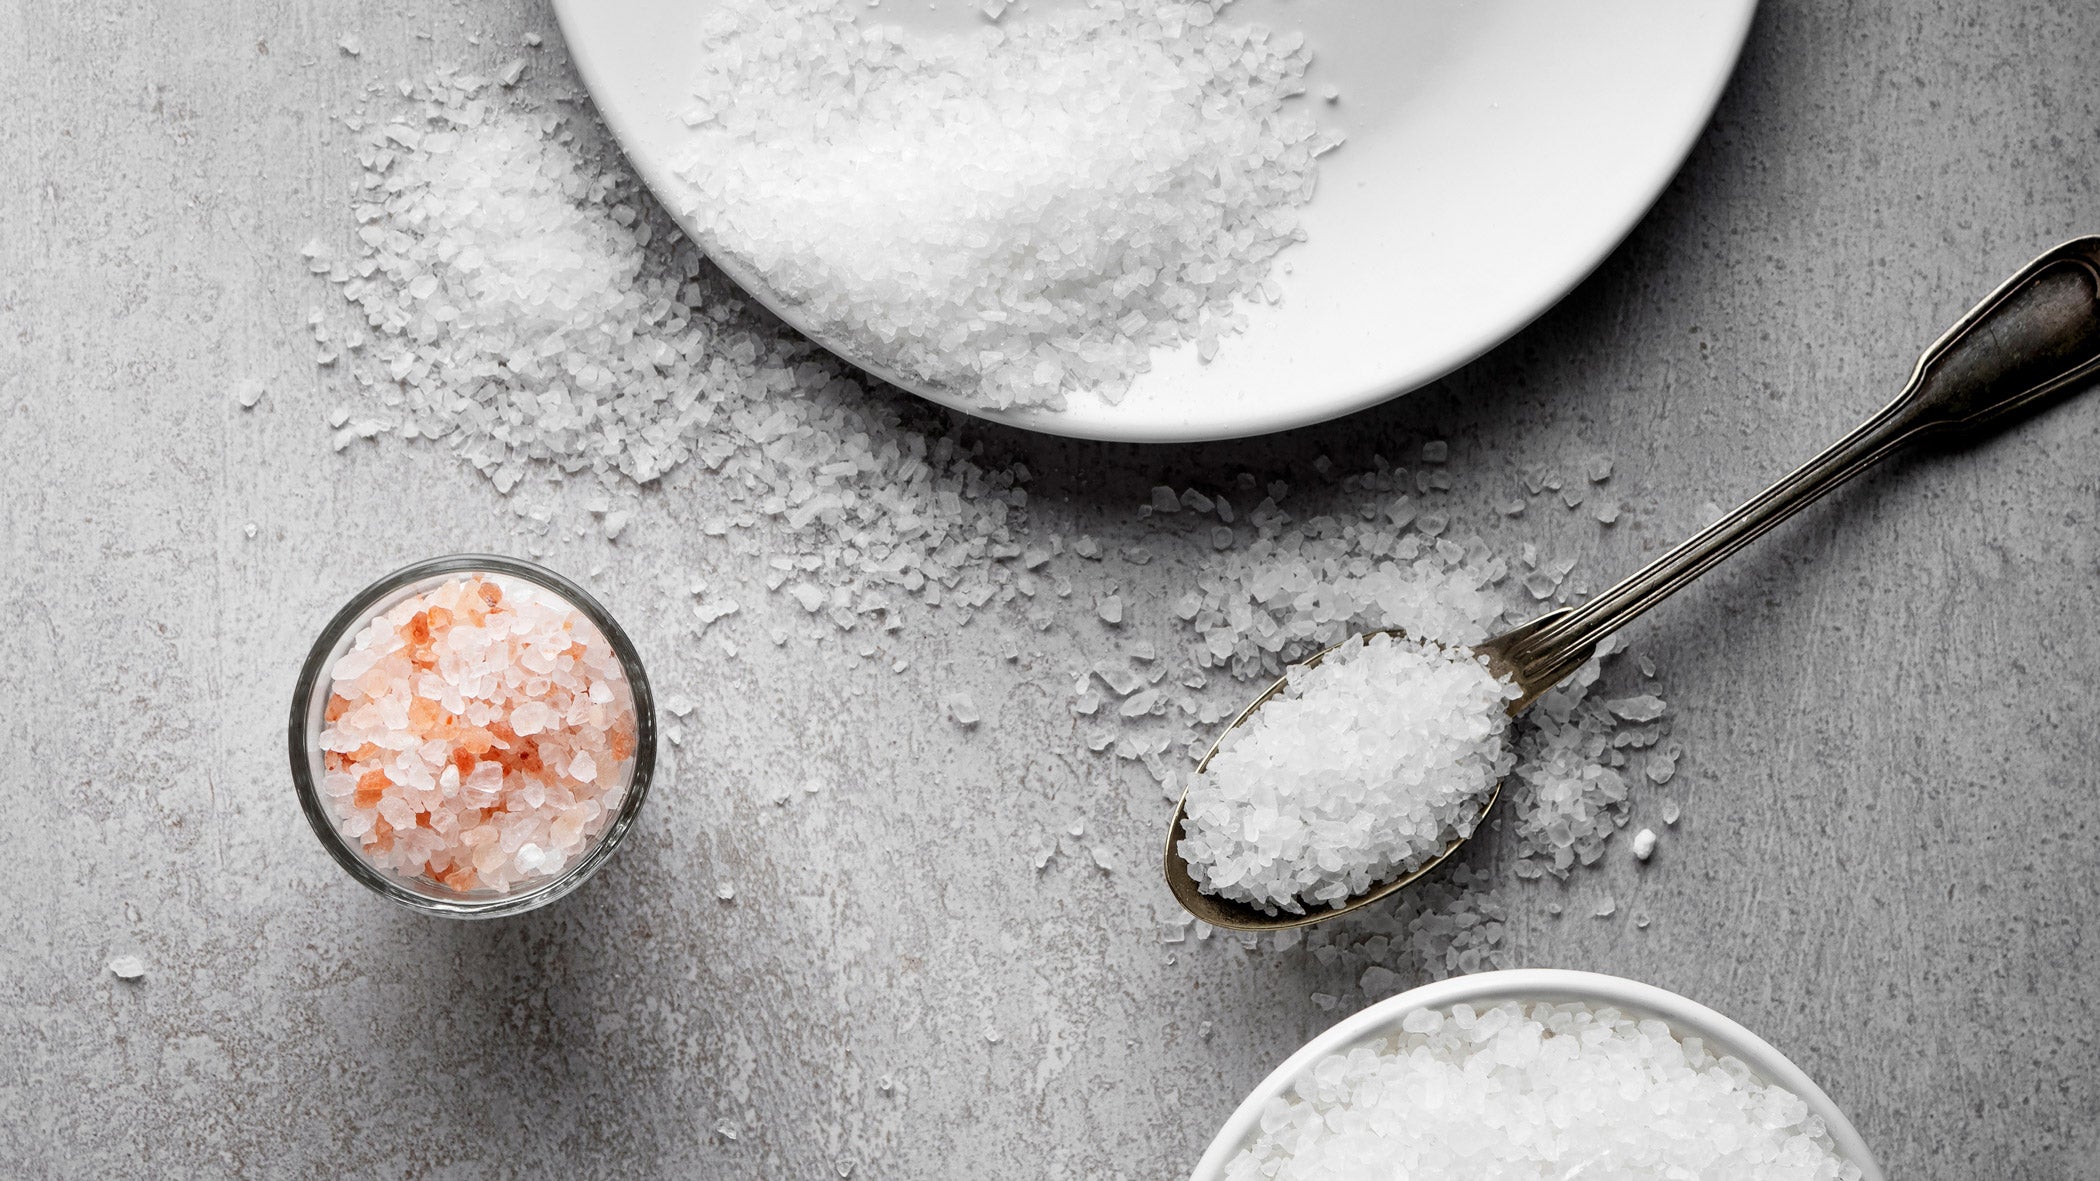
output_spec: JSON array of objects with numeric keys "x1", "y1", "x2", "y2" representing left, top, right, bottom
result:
[{"x1": 1180, "y1": 635, "x2": 1520, "y2": 914}]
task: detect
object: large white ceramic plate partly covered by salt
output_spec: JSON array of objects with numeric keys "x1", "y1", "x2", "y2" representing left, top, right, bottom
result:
[{"x1": 554, "y1": 0, "x2": 1756, "y2": 441}]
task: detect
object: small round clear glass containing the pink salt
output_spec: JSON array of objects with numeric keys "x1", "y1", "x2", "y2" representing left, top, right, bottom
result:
[{"x1": 290, "y1": 553, "x2": 655, "y2": 918}]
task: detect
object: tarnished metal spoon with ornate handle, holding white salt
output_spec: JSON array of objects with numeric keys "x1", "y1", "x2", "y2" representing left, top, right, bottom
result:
[{"x1": 1166, "y1": 237, "x2": 2100, "y2": 931}]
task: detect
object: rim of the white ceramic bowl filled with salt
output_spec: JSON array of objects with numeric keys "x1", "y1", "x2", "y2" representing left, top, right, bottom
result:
[{"x1": 1193, "y1": 969, "x2": 1884, "y2": 1181}]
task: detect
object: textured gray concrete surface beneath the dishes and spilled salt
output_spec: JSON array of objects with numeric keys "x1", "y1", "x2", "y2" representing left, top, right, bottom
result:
[{"x1": 0, "y1": 0, "x2": 2100, "y2": 1179}]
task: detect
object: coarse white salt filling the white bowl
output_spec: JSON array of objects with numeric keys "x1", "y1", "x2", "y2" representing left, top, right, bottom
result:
[{"x1": 1224, "y1": 1000, "x2": 1861, "y2": 1181}]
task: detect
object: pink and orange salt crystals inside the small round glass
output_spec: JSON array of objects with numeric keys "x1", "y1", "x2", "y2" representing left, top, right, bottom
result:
[{"x1": 321, "y1": 576, "x2": 636, "y2": 893}]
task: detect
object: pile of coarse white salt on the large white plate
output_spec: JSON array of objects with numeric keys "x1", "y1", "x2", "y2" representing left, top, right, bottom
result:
[{"x1": 680, "y1": 0, "x2": 1340, "y2": 408}]
